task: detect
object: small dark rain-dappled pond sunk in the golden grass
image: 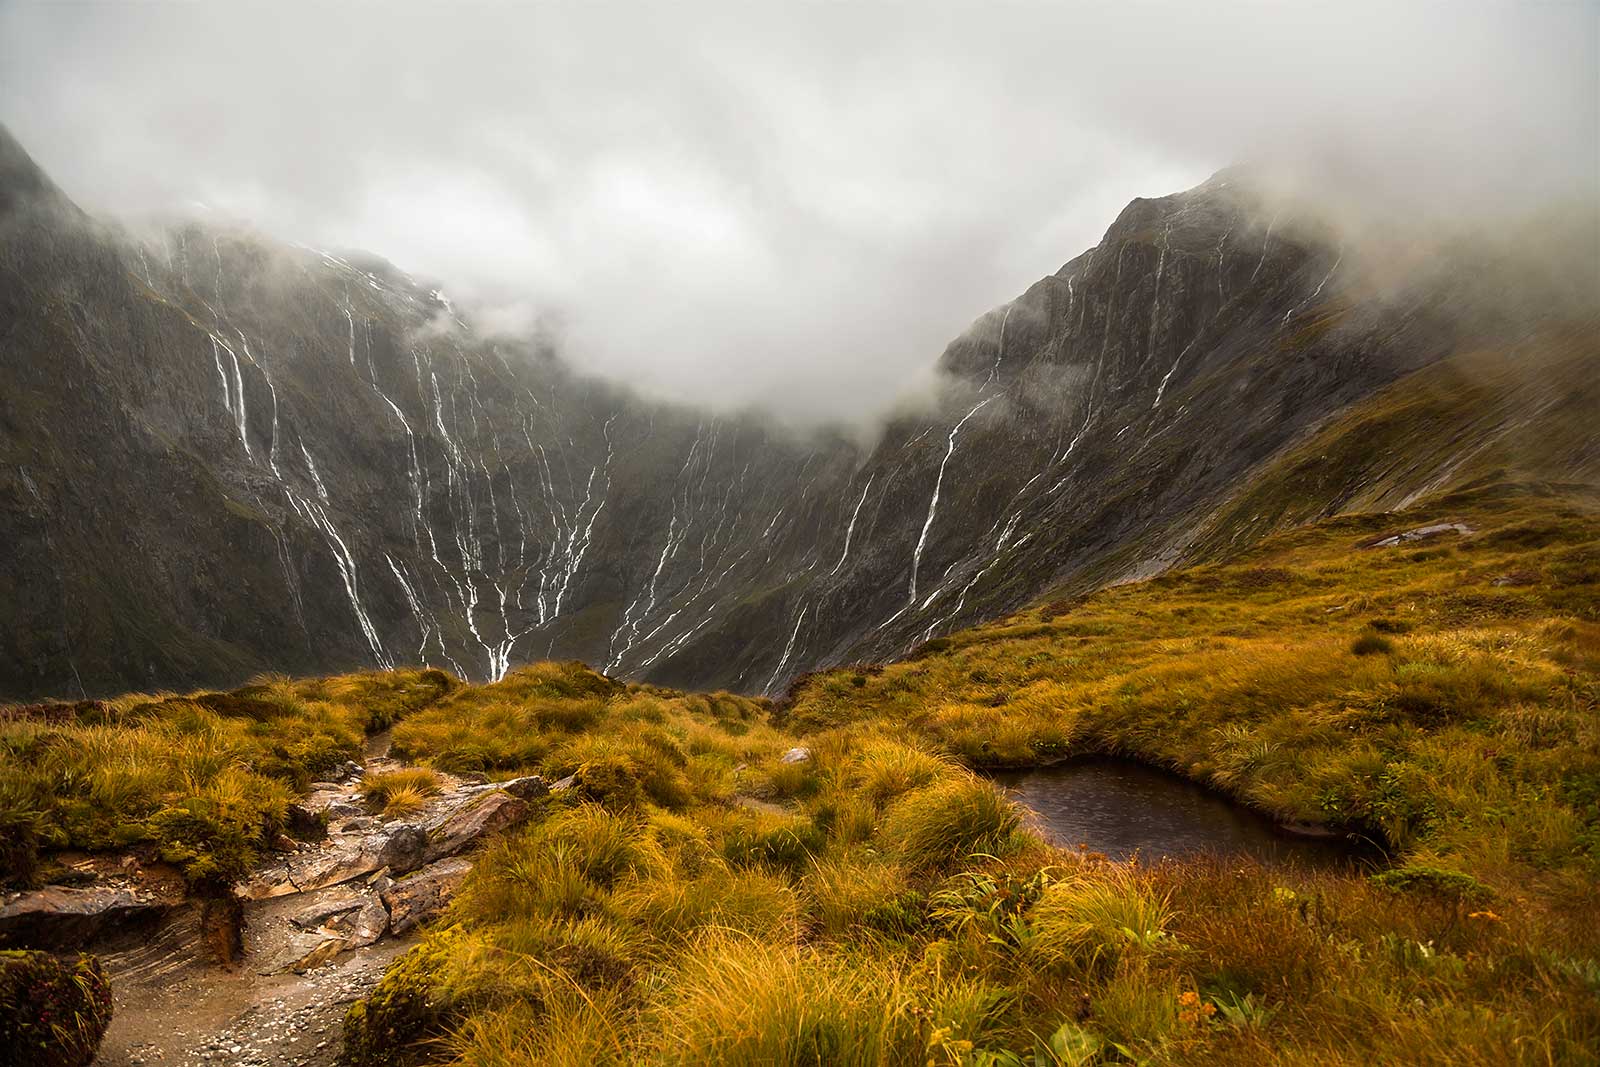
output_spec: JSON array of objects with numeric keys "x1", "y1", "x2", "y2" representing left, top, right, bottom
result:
[{"x1": 994, "y1": 758, "x2": 1366, "y2": 867}]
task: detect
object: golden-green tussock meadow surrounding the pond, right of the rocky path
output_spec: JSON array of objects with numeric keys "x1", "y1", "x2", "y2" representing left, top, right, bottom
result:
[{"x1": 331, "y1": 488, "x2": 1600, "y2": 1067}]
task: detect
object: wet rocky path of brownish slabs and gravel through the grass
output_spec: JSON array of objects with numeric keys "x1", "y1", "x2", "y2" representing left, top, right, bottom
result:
[{"x1": 82, "y1": 745, "x2": 547, "y2": 1067}]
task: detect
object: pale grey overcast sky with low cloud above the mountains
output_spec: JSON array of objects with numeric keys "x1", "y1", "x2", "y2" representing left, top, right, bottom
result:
[{"x1": 0, "y1": 0, "x2": 1600, "y2": 418}]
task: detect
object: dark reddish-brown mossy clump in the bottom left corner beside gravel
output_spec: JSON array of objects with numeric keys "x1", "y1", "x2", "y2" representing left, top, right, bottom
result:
[{"x1": 0, "y1": 950, "x2": 112, "y2": 1067}]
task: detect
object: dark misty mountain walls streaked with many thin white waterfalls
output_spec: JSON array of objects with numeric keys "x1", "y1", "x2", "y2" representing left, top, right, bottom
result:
[{"x1": 0, "y1": 130, "x2": 1600, "y2": 697}]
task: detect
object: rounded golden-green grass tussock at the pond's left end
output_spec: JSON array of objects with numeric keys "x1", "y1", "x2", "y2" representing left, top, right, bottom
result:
[{"x1": 878, "y1": 774, "x2": 1021, "y2": 867}]
